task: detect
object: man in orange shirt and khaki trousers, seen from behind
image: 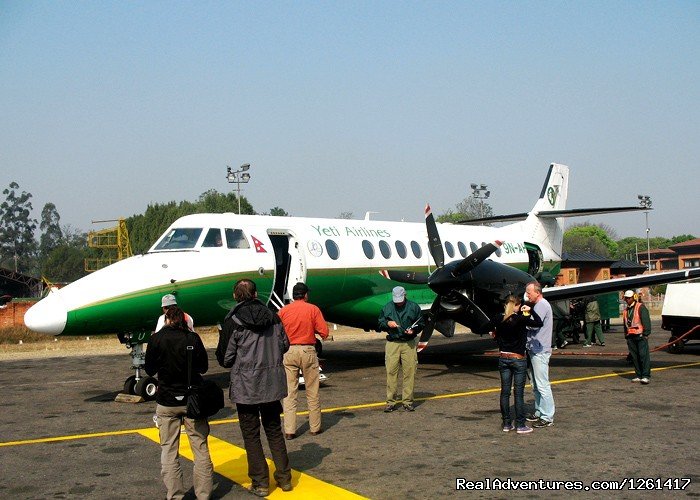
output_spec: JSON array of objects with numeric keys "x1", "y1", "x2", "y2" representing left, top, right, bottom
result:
[{"x1": 279, "y1": 282, "x2": 328, "y2": 439}]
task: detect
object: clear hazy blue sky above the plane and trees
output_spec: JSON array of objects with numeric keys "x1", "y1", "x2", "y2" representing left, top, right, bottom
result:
[{"x1": 0, "y1": 0, "x2": 700, "y2": 238}]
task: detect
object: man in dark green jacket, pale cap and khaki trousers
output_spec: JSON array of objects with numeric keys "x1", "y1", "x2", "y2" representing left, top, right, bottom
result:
[{"x1": 379, "y1": 286, "x2": 424, "y2": 413}]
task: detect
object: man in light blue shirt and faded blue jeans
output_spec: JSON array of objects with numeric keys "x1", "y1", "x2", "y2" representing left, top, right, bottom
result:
[{"x1": 525, "y1": 281, "x2": 554, "y2": 428}]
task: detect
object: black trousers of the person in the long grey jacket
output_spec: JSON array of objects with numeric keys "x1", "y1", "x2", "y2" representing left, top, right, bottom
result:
[{"x1": 236, "y1": 401, "x2": 292, "y2": 488}]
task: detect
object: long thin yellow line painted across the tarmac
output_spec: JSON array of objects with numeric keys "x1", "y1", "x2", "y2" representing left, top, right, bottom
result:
[{"x1": 0, "y1": 361, "x2": 700, "y2": 448}]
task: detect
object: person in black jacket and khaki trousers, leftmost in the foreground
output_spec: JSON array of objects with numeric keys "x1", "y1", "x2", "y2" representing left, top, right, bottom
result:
[{"x1": 145, "y1": 306, "x2": 214, "y2": 500}]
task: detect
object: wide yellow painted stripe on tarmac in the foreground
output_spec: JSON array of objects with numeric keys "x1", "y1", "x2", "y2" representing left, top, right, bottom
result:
[{"x1": 139, "y1": 428, "x2": 365, "y2": 499}]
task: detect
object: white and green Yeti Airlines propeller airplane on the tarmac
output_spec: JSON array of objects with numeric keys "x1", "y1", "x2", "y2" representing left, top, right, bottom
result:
[{"x1": 24, "y1": 163, "x2": 700, "y2": 400}]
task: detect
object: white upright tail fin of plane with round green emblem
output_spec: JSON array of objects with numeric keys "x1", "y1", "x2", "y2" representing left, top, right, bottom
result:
[{"x1": 521, "y1": 163, "x2": 569, "y2": 258}]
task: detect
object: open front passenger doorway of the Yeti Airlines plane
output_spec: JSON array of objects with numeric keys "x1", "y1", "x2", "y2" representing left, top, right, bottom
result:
[{"x1": 268, "y1": 231, "x2": 306, "y2": 309}]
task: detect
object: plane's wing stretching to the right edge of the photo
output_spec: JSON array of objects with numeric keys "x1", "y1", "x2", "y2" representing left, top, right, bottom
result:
[{"x1": 542, "y1": 267, "x2": 700, "y2": 300}]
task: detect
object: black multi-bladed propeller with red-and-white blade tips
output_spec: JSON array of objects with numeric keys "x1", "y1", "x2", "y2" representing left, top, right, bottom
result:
[{"x1": 381, "y1": 205, "x2": 503, "y2": 352}]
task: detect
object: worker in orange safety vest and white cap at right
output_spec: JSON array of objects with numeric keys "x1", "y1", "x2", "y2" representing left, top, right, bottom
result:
[{"x1": 623, "y1": 290, "x2": 651, "y2": 384}]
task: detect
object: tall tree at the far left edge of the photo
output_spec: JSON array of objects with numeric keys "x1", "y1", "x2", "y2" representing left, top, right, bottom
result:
[{"x1": 0, "y1": 182, "x2": 37, "y2": 274}]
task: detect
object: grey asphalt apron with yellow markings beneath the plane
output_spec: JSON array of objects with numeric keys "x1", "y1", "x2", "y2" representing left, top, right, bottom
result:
[{"x1": 0, "y1": 322, "x2": 700, "y2": 499}]
